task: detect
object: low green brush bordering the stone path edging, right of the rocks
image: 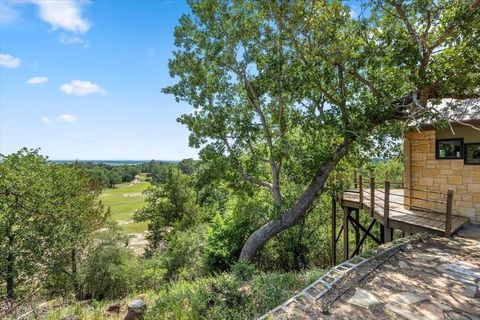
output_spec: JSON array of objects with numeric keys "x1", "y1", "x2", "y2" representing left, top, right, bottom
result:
[{"x1": 146, "y1": 267, "x2": 323, "y2": 320}]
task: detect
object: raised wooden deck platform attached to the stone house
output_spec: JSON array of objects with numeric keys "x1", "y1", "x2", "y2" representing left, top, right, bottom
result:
[{"x1": 339, "y1": 189, "x2": 468, "y2": 236}]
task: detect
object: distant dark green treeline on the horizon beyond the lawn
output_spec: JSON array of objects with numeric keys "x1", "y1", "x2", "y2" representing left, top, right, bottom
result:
[{"x1": 68, "y1": 159, "x2": 195, "y2": 188}]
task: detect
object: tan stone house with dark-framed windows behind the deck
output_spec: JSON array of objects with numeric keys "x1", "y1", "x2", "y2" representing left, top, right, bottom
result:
[{"x1": 404, "y1": 100, "x2": 480, "y2": 222}]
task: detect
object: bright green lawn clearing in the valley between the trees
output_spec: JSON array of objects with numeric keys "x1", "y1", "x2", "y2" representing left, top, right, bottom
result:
[{"x1": 100, "y1": 179, "x2": 150, "y2": 233}]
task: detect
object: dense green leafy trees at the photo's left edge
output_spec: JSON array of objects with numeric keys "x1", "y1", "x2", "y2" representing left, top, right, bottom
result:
[{"x1": 0, "y1": 149, "x2": 108, "y2": 298}]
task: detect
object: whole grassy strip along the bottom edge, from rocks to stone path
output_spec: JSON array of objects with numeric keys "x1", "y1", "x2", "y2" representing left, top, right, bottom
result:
[{"x1": 45, "y1": 269, "x2": 325, "y2": 320}]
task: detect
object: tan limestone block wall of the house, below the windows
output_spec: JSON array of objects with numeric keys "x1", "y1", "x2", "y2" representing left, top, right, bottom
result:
[{"x1": 404, "y1": 130, "x2": 480, "y2": 222}]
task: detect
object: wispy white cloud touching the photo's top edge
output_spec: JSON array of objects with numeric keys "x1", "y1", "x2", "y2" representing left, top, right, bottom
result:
[{"x1": 31, "y1": 0, "x2": 91, "y2": 33}]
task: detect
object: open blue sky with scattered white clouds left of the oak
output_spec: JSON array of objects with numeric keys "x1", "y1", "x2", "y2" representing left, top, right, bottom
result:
[{"x1": 0, "y1": 0, "x2": 198, "y2": 160}]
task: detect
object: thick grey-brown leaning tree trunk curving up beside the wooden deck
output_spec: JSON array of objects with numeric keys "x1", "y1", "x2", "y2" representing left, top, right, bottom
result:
[{"x1": 240, "y1": 141, "x2": 350, "y2": 261}]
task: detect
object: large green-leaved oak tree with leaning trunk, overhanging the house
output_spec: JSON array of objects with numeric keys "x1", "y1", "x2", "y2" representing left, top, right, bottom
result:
[{"x1": 164, "y1": 0, "x2": 480, "y2": 260}]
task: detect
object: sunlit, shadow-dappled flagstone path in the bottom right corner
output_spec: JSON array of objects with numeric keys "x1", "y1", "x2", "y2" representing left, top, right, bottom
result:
[{"x1": 267, "y1": 225, "x2": 480, "y2": 320}]
